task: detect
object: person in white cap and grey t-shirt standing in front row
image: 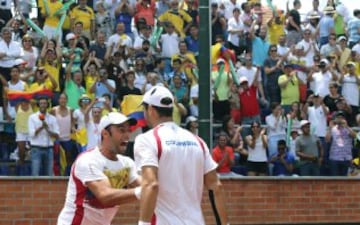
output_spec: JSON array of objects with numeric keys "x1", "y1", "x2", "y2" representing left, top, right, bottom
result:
[{"x1": 295, "y1": 120, "x2": 323, "y2": 176}]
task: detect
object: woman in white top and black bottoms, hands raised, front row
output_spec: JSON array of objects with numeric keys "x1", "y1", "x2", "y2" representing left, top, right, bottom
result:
[{"x1": 245, "y1": 122, "x2": 269, "y2": 176}]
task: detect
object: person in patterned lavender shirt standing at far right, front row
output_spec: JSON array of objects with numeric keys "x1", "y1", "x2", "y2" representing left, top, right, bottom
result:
[{"x1": 326, "y1": 111, "x2": 356, "y2": 176}]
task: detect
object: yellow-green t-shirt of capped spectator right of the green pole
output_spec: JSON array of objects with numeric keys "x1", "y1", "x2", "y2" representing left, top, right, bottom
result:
[{"x1": 278, "y1": 74, "x2": 300, "y2": 105}]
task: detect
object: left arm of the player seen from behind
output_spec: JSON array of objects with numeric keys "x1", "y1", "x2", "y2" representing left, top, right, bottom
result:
[{"x1": 139, "y1": 166, "x2": 159, "y2": 224}]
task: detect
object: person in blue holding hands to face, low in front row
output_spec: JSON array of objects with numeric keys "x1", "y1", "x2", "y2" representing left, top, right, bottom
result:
[{"x1": 270, "y1": 140, "x2": 295, "y2": 176}]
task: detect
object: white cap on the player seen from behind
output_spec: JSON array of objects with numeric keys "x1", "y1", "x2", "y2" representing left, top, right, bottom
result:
[{"x1": 142, "y1": 86, "x2": 174, "y2": 108}]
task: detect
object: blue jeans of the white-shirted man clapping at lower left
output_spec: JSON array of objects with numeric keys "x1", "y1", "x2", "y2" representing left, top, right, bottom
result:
[{"x1": 31, "y1": 146, "x2": 54, "y2": 176}]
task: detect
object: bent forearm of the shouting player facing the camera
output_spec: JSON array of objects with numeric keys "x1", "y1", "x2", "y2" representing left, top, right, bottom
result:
[{"x1": 86, "y1": 179, "x2": 141, "y2": 207}]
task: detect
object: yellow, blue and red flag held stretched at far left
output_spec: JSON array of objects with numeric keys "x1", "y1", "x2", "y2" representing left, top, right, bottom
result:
[{"x1": 7, "y1": 89, "x2": 53, "y2": 106}]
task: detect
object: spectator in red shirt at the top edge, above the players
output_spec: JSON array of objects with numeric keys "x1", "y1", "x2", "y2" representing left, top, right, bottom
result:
[{"x1": 135, "y1": 0, "x2": 156, "y2": 27}]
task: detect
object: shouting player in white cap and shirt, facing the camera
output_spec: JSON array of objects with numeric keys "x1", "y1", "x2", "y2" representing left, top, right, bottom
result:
[{"x1": 57, "y1": 113, "x2": 141, "y2": 224}]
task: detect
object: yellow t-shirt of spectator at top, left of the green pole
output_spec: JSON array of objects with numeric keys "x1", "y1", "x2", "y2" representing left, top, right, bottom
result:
[{"x1": 159, "y1": 9, "x2": 192, "y2": 37}]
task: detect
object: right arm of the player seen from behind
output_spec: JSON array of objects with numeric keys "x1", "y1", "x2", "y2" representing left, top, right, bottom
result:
[{"x1": 204, "y1": 170, "x2": 228, "y2": 224}]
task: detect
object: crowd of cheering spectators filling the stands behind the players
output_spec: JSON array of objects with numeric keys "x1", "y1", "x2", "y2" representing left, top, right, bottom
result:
[{"x1": 0, "y1": 0, "x2": 360, "y2": 176}]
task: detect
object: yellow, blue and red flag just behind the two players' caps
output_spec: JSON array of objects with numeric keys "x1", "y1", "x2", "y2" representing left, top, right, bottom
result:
[{"x1": 121, "y1": 95, "x2": 146, "y2": 130}]
